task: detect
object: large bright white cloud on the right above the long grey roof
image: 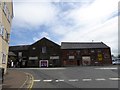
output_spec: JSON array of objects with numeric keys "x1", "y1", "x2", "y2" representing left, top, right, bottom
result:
[{"x1": 60, "y1": 0, "x2": 118, "y2": 54}]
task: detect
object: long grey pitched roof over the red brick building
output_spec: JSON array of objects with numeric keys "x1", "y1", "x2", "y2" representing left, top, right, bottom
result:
[{"x1": 61, "y1": 42, "x2": 109, "y2": 49}]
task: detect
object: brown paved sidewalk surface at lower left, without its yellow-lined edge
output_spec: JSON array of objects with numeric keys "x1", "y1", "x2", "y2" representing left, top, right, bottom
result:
[{"x1": 2, "y1": 69, "x2": 29, "y2": 90}]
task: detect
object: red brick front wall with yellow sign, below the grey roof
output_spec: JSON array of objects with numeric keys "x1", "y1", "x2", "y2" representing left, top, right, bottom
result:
[{"x1": 61, "y1": 48, "x2": 112, "y2": 66}]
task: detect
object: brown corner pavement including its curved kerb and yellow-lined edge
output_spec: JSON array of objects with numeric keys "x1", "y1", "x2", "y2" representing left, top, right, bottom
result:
[{"x1": 2, "y1": 69, "x2": 33, "y2": 90}]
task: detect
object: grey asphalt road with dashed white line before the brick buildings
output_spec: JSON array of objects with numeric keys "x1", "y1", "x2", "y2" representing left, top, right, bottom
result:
[{"x1": 10, "y1": 66, "x2": 120, "y2": 88}]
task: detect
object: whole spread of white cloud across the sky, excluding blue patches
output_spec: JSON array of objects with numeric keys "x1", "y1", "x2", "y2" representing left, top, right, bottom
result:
[{"x1": 13, "y1": 0, "x2": 119, "y2": 53}]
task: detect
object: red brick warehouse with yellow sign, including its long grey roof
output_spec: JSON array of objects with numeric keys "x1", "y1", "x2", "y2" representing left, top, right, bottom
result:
[{"x1": 61, "y1": 42, "x2": 112, "y2": 66}]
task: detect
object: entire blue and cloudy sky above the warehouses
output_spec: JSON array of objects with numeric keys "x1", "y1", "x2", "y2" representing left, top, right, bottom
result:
[{"x1": 10, "y1": 0, "x2": 119, "y2": 55}]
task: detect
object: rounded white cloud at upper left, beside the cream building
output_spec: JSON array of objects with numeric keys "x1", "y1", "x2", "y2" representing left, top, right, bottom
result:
[{"x1": 13, "y1": 2, "x2": 57, "y2": 28}]
